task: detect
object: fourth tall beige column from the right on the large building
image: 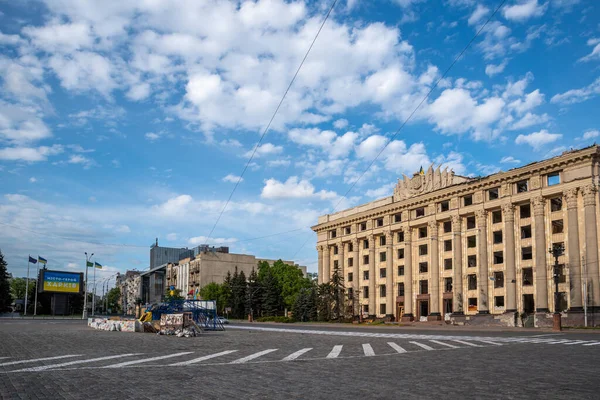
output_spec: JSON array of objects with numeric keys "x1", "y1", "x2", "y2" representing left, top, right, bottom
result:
[{"x1": 502, "y1": 203, "x2": 517, "y2": 313}]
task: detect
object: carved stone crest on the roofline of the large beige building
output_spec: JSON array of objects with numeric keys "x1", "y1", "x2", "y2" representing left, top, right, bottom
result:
[{"x1": 394, "y1": 164, "x2": 469, "y2": 201}]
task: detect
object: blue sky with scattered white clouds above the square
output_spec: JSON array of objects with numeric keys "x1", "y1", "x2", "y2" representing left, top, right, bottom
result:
[{"x1": 0, "y1": 0, "x2": 600, "y2": 279}]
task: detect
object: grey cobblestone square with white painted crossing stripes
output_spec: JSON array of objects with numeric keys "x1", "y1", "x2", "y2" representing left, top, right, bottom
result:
[{"x1": 0, "y1": 320, "x2": 600, "y2": 399}]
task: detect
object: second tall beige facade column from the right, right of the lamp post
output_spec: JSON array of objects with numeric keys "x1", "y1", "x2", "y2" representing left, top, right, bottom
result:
[{"x1": 564, "y1": 188, "x2": 580, "y2": 311}]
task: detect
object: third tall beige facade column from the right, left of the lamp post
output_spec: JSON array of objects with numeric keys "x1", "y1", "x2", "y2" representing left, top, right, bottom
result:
[{"x1": 532, "y1": 196, "x2": 548, "y2": 313}]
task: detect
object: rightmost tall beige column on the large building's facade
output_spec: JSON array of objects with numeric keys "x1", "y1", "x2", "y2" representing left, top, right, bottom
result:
[{"x1": 583, "y1": 184, "x2": 600, "y2": 312}]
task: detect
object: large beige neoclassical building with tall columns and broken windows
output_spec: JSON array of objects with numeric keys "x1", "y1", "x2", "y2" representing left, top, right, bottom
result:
[{"x1": 312, "y1": 145, "x2": 600, "y2": 325}]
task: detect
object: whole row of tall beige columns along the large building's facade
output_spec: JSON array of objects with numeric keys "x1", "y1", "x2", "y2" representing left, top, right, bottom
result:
[{"x1": 317, "y1": 185, "x2": 600, "y2": 317}]
